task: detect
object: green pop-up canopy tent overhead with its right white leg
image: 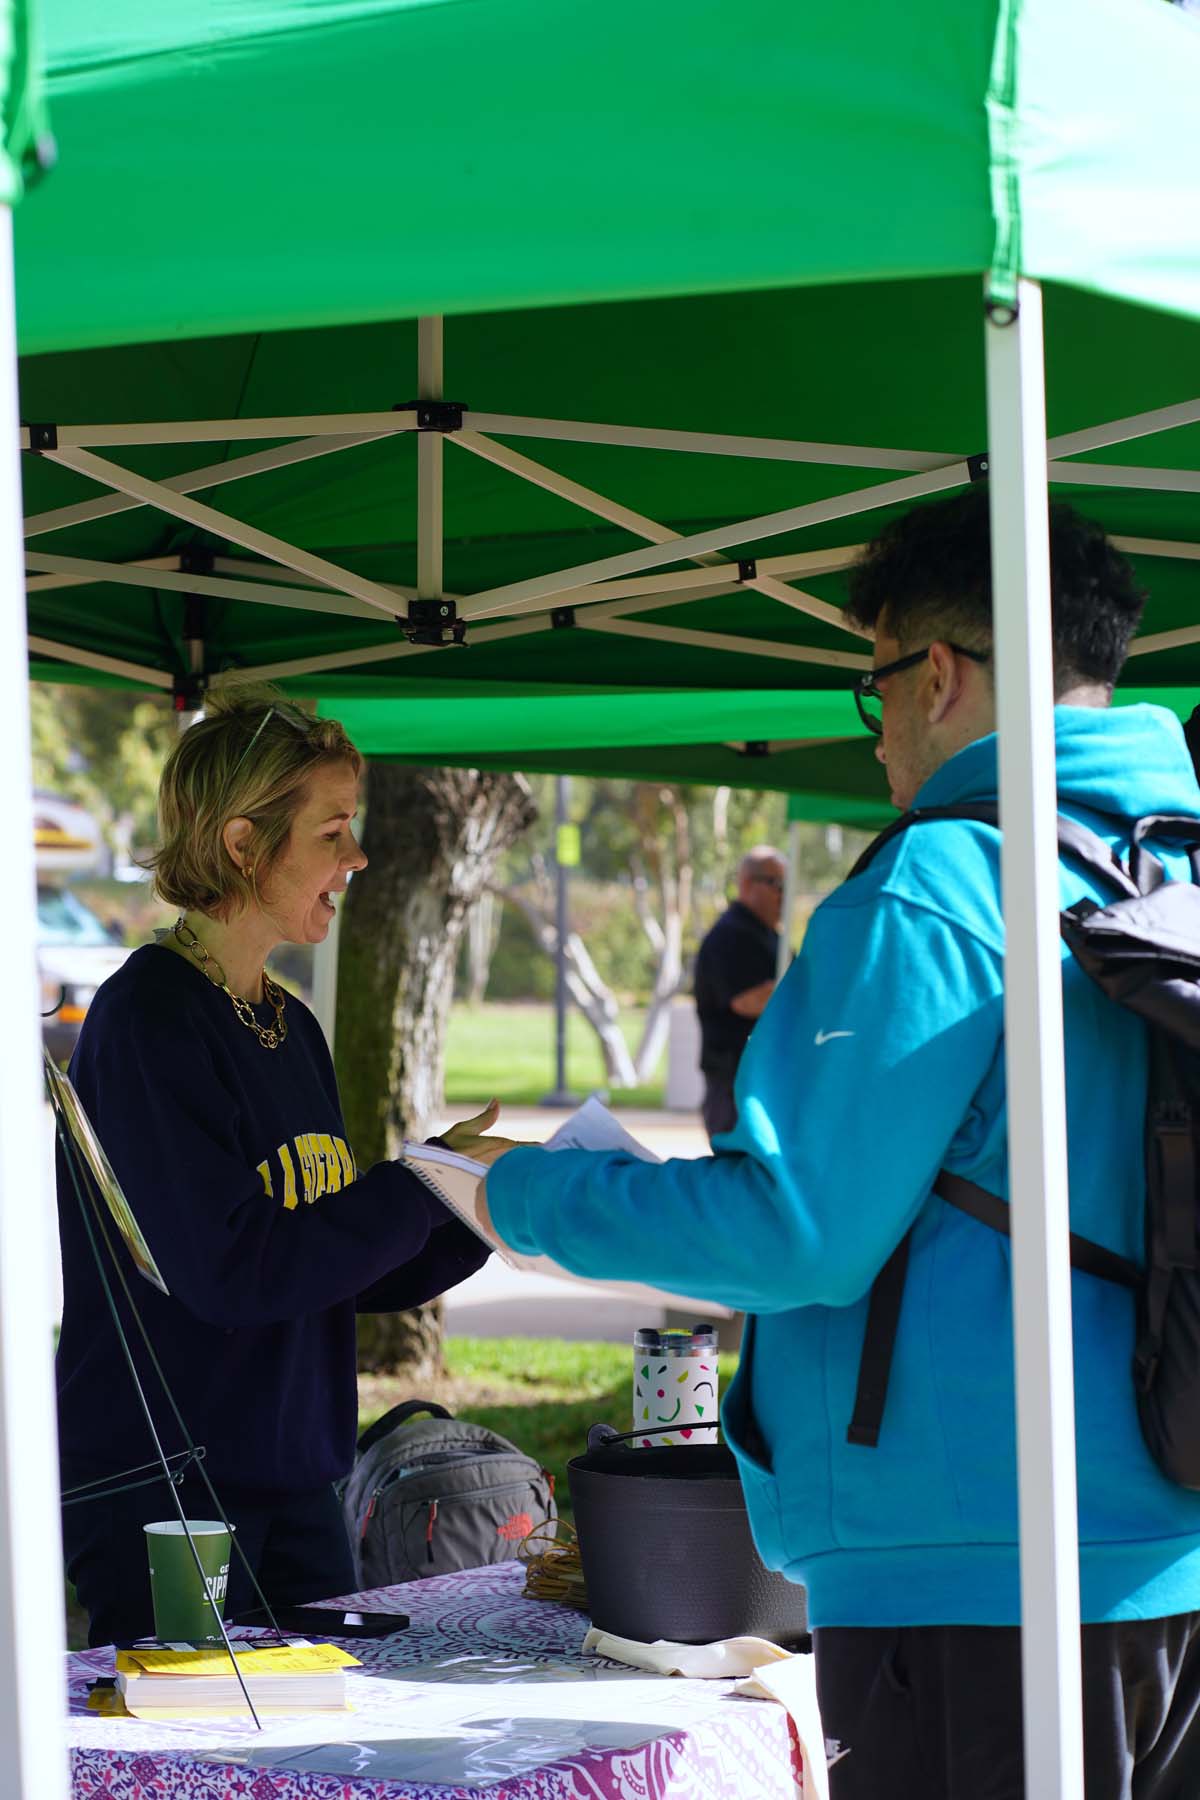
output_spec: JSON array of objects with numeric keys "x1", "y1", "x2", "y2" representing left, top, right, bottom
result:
[{"x1": 0, "y1": 0, "x2": 1200, "y2": 1796}]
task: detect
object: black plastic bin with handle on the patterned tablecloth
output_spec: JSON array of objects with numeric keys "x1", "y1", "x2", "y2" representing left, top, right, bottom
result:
[{"x1": 567, "y1": 1427, "x2": 808, "y2": 1647}]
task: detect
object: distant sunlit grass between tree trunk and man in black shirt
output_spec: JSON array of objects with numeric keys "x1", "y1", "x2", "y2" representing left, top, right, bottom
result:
[{"x1": 446, "y1": 1001, "x2": 666, "y2": 1107}]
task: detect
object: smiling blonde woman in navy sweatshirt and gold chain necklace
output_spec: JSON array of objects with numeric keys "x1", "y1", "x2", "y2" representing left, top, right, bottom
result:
[{"x1": 58, "y1": 693, "x2": 495, "y2": 1643}]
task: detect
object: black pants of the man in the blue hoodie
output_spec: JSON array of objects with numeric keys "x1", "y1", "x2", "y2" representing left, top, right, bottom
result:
[{"x1": 813, "y1": 1613, "x2": 1200, "y2": 1800}]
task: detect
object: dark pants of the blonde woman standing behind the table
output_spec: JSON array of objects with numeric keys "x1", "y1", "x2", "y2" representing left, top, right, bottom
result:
[{"x1": 63, "y1": 1476, "x2": 358, "y2": 1643}]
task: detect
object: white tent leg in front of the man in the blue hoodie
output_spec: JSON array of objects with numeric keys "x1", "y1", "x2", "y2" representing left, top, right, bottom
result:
[{"x1": 984, "y1": 281, "x2": 1083, "y2": 1800}]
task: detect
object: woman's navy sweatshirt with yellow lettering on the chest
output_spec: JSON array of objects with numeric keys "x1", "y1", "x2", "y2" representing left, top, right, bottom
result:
[{"x1": 58, "y1": 945, "x2": 488, "y2": 1494}]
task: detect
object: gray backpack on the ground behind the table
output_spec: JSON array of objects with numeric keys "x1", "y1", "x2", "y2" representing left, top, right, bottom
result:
[{"x1": 342, "y1": 1400, "x2": 556, "y2": 1588}]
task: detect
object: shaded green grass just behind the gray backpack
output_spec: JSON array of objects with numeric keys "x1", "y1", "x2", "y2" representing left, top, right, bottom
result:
[{"x1": 360, "y1": 1337, "x2": 738, "y2": 1519}]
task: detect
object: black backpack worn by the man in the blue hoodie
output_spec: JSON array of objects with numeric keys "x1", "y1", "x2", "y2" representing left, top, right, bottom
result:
[{"x1": 847, "y1": 805, "x2": 1200, "y2": 1490}]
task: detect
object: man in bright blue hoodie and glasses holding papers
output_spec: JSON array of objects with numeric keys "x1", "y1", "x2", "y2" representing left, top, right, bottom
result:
[{"x1": 488, "y1": 488, "x2": 1200, "y2": 1800}]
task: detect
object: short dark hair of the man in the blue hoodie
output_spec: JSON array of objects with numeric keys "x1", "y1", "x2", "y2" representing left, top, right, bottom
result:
[{"x1": 847, "y1": 482, "x2": 1146, "y2": 693}]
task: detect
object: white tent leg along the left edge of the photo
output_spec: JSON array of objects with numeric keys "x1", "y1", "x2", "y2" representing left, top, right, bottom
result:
[{"x1": 0, "y1": 207, "x2": 68, "y2": 1800}]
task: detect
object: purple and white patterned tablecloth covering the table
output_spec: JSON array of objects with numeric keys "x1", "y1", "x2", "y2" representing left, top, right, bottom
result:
[{"x1": 68, "y1": 1562, "x2": 802, "y2": 1800}]
